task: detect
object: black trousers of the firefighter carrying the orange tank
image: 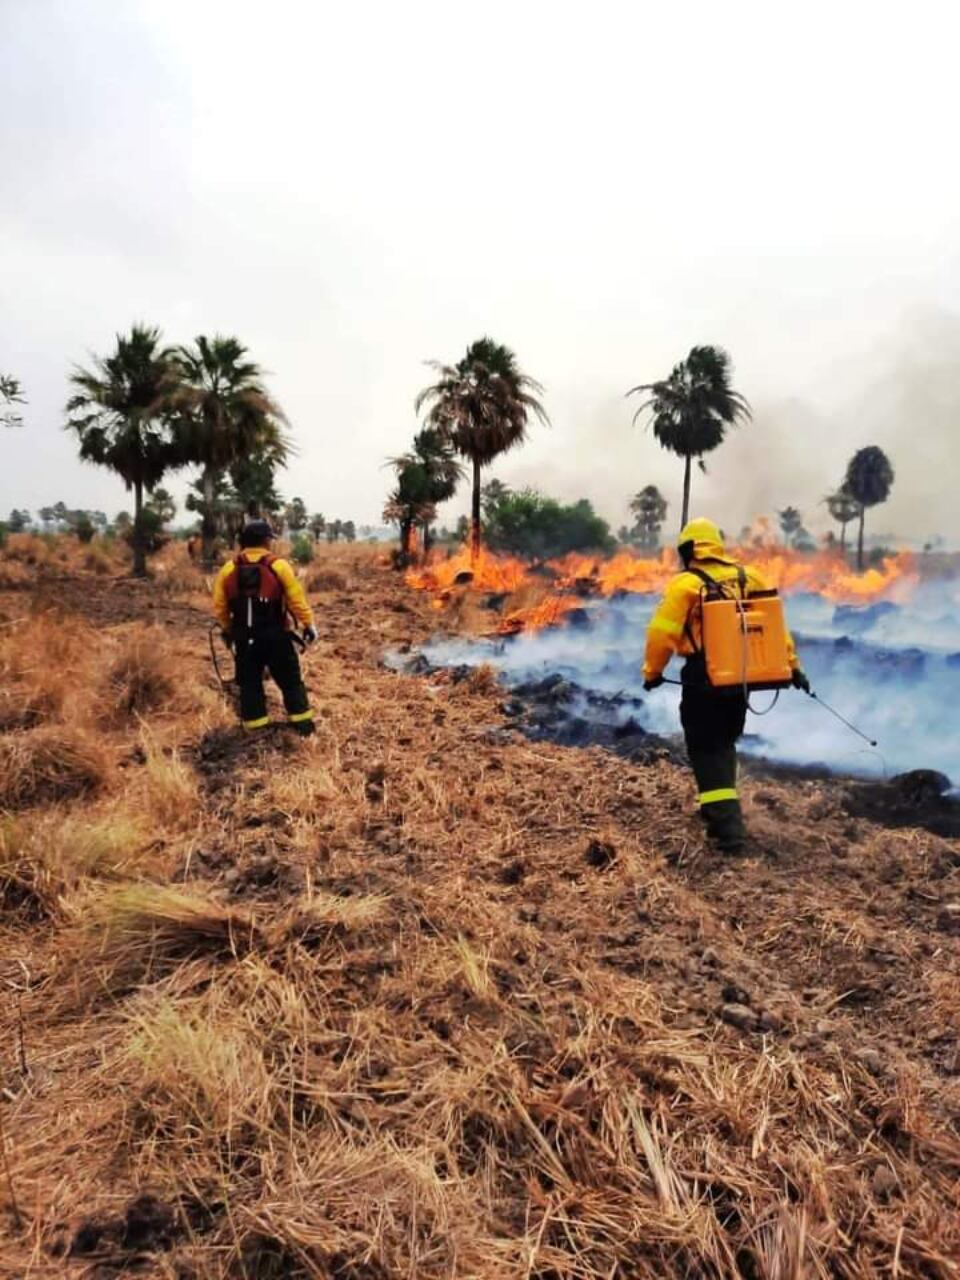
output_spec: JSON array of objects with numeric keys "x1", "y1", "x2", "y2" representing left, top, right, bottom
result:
[{"x1": 680, "y1": 654, "x2": 746, "y2": 846}]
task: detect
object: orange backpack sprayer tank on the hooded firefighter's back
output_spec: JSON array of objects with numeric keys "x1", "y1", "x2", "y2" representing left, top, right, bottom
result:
[{"x1": 687, "y1": 568, "x2": 792, "y2": 692}]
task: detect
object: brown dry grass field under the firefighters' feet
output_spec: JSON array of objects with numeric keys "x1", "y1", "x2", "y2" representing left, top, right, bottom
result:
[{"x1": 0, "y1": 538, "x2": 960, "y2": 1280}]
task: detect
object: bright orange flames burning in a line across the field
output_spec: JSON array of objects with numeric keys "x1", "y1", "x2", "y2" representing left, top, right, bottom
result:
[{"x1": 406, "y1": 537, "x2": 918, "y2": 635}]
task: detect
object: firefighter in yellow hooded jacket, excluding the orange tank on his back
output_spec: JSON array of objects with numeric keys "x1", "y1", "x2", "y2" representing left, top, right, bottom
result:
[{"x1": 644, "y1": 518, "x2": 810, "y2": 854}]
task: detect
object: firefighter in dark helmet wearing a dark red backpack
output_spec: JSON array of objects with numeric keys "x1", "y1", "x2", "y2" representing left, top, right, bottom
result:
[{"x1": 214, "y1": 520, "x2": 316, "y2": 737}]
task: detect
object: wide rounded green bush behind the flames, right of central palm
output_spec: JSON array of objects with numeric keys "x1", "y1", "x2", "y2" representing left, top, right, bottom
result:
[{"x1": 486, "y1": 489, "x2": 616, "y2": 557}]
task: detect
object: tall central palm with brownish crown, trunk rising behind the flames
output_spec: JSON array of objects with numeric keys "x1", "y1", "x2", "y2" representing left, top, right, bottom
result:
[{"x1": 416, "y1": 338, "x2": 549, "y2": 558}]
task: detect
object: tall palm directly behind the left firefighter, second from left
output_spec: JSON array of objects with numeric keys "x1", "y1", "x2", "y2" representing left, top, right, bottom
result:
[{"x1": 170, "y1": 334, "x2": 291, "y2": 567}]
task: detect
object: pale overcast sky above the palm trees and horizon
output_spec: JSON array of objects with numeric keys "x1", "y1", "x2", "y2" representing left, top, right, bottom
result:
[{"x1": 0, "y1": 0, "x2": 960, "y2": 538}]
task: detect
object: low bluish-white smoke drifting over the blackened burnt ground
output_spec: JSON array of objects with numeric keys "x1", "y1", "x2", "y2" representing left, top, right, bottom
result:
[{"x1": 425, "y1": 582, "x2": 960, "y2": 782}]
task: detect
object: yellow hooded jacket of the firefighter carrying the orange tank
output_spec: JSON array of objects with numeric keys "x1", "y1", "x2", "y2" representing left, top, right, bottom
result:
[{"x1": 644, "y1": 518, "x2": 800, "y2": 680}]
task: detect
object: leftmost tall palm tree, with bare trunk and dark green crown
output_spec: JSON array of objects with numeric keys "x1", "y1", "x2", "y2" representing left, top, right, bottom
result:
[{"x1": 67, "y1": 325, "x2": 183, "y2": 577}]
